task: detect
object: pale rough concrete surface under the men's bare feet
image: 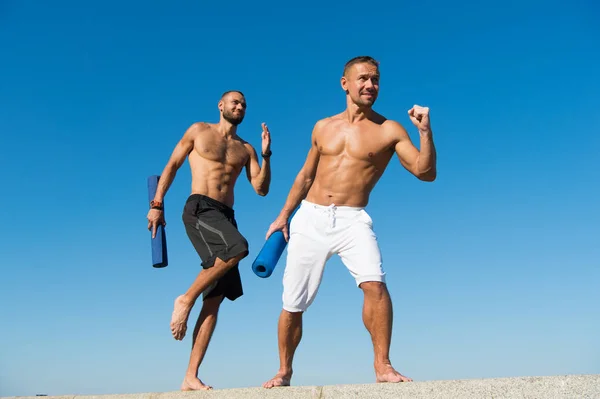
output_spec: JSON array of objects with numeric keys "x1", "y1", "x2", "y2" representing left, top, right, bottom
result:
[{"x1": 7, "y1": 374, "x2": 600, "y2": 399}]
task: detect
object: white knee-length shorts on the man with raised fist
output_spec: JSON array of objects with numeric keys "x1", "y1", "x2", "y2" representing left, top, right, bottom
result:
[{"x1": 282, "y1": 200, "x2": 385, "y2": 312}]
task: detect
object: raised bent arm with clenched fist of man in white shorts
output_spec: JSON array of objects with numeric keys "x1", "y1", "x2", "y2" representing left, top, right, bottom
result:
[{"x1": 394, "y1": 105, "x2": 437, "y2": 181}]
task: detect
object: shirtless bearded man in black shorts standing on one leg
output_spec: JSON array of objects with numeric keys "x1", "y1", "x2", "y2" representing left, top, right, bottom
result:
[{"x1": 148, "y1": 91, "x2": 271, "y2": 391}]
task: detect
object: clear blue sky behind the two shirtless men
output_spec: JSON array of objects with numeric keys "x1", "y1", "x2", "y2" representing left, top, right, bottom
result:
[{"x1": 0, "y1": 0, "x2": 600, "y2": 396}]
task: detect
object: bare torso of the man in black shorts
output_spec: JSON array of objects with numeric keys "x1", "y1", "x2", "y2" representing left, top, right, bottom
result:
[{"x1": 188, "y1": 123, "x2": 250, "y2": 207}]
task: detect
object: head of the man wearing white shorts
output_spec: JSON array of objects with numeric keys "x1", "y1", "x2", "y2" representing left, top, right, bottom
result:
[{"x1": 341, "y1": 58, "x2": 379, "y2": 108}]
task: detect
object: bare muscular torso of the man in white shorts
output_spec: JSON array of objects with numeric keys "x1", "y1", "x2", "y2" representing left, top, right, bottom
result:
[{"x1": 306, "y1": 114, "x2": 397, "y2": 207}]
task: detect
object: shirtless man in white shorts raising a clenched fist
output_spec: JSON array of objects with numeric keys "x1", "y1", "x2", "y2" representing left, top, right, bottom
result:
[{"x1": 263, "y1": 56, "x2": 436, "y2": 388}]
